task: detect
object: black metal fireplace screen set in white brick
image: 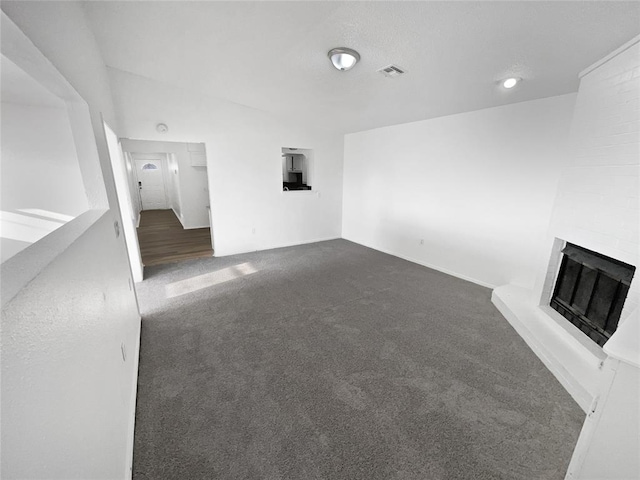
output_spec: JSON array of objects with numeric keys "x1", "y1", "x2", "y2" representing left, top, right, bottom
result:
[{"x1": 551, "y1": 243, "x2": 635, "y2": 346}]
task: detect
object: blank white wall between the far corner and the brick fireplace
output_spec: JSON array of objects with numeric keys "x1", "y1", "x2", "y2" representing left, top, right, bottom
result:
[{"x1": 342, "y1": 94, "x2": 575, "y2": 288}]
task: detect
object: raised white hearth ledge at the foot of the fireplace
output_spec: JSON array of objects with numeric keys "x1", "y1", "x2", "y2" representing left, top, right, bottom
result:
[{"x1": 491, "y1": 285, "x2": 607, "y2": 413}]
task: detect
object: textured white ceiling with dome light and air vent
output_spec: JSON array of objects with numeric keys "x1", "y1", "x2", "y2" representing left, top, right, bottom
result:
[{"x1": 85, "y1": 1, "x2": 640, "y2": 133}]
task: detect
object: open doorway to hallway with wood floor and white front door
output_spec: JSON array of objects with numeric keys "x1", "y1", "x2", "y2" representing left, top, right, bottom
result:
[{"x1": 115, "y1": 139, "x2": 213, "y2": 274}]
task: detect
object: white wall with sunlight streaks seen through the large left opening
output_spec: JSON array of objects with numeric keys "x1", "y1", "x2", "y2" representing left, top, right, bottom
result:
[{"x1": 0, "y1": 102, "x2": 89, "y2": 262}]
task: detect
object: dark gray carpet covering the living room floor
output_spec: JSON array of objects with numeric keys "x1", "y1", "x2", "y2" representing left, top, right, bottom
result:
[{"x1": 133, "y1": 240, "x2": 584, "y2": 480}]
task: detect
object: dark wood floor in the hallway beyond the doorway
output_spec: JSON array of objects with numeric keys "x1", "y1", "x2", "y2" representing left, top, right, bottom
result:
[{"x1": 138, "y1": 210, "x2": 213, "y2": 267}]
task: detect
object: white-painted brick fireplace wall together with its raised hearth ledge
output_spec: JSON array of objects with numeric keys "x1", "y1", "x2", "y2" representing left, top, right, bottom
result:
[{"x1": 492, "y1": 36, "x2": 640, "y2": 412}]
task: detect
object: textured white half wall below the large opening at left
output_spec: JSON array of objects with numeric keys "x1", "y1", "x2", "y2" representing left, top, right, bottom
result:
[{"x1": 2, "y1": 214, "x2": 139, "y2": 480}]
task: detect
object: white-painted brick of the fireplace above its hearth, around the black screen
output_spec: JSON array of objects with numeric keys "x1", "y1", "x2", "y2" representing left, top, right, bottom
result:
[{"x1": 537, "y1": 38, "x2": 640, "y2": 323}]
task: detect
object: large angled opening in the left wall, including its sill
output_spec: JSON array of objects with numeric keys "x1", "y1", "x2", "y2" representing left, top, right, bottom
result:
[{"x1": 0, "y1": 13, "x2": 110, "y2": 312}]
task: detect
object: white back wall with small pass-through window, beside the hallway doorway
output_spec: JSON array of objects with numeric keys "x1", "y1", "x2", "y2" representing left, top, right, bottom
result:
[{"x1": 109, "y1": 69, "x2": 343, "y2": 255}]
